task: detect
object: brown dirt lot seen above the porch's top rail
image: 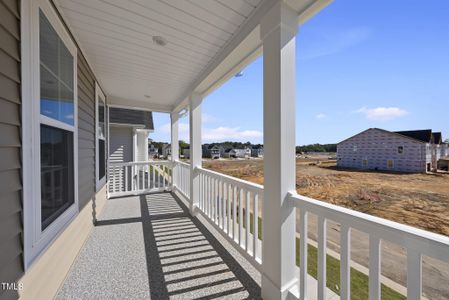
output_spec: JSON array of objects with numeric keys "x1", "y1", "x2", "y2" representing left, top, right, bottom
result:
[{"x1": 203, "y1": 157, "x2": 449, "y2": 236}]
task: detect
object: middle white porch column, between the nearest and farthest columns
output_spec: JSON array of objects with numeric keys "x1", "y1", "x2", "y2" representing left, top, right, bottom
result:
[{"x1": 189, "y1": 93, "x2": 203, "y2": 215}]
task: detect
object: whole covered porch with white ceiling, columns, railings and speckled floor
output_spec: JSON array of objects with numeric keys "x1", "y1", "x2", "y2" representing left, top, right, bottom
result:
[{"x1": 47, "y1": 0, "x2": 449, "y2": 299}]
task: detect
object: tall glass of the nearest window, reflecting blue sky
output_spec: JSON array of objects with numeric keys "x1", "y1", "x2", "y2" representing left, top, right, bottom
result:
[{"x1": 39, "y1": 10, "x2": 75, "y2": 231}]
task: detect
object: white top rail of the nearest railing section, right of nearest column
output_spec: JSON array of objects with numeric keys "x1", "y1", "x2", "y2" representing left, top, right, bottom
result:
[{"x1": 289, "y1": 193, "x2": 449, "y2": 263}]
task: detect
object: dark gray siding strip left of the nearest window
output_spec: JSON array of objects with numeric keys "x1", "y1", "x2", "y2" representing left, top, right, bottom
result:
[{"x1": 0, "y1": 0, "x2": 24, "y2": 299}]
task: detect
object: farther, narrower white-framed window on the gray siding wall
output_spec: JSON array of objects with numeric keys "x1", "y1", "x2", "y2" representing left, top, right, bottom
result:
[{"x1": 95, "y1": 84, "x2": 107, "y2": 191}]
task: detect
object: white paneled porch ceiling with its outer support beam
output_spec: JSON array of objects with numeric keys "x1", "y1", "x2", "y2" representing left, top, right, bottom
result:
[{"x1": 53, "y1": 0, "x2": 331, "y2": 112}]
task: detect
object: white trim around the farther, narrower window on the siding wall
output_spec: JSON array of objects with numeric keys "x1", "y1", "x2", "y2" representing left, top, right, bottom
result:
[{"x1": 95, "y1": 82, "x2": 109, "y2": 192}]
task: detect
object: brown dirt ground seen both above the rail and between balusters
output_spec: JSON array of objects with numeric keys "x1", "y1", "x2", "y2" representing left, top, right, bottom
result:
[{"x1": 203, "y1": 157, "x2": 449, "y2": 299}]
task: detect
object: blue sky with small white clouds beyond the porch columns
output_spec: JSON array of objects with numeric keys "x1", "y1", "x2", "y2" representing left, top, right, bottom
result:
[{"x1": 150, "y1": 0, "x2": 449, "y2": 145}]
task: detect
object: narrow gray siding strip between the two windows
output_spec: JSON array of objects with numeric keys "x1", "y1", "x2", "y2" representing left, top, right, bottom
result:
[{"x1": 78, "y1": 52, "x2": 96, "y2": 210}]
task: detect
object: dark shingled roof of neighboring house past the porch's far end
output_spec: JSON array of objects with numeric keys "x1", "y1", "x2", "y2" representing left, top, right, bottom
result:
[{"x1": 109, "y1": 107, "x2": 154, "y2": 130}]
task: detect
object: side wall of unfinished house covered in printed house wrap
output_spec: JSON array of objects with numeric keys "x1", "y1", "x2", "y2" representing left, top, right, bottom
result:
[{"x1": 337, "y1": 129, "x2": 430, "y2": 172}]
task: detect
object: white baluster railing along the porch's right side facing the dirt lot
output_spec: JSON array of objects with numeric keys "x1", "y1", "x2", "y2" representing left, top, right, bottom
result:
[{"x1": 171, "y1": 168, "x2": 449, "y2": 299}]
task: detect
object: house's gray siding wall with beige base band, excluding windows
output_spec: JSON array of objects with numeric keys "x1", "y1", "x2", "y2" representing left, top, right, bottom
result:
[{"x1": 13, "y1": 0, "x2": 107, "y2": 299}]
